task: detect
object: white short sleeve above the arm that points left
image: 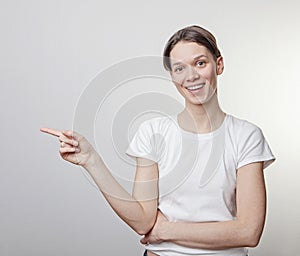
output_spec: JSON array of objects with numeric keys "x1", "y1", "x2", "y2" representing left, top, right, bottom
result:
[{"x1": 125, "y1": 121, "x2": 157, "y2": 162}]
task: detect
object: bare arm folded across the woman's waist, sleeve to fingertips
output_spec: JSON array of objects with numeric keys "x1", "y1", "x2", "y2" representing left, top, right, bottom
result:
[{"x1": 141, "y1": 162, "x2": 266, "y2": 249}]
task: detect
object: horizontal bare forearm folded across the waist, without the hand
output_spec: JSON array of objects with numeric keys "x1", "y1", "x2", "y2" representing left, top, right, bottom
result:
[{"x1": 160, "y1": 220, "x2": 260, "y2": 249}]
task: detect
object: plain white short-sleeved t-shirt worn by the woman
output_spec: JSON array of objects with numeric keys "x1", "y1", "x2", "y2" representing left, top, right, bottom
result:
[{"x1": 126, "y1": 114, "x2": 275, "y2": 256}]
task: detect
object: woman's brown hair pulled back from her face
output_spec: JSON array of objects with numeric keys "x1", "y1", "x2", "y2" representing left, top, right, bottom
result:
[{"x1": 163, "y1": 25, "x2": 221, "y2": 71}]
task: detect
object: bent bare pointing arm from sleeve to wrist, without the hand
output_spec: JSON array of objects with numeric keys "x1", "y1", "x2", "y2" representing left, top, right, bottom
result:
[{"x1": 85, "y1": 152, "x2": 158, "y2": 235}]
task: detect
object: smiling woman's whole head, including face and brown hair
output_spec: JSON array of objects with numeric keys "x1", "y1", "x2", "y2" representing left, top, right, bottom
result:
[{"x1": 163, "y1": 26, "x2": 224, "y2": 110}]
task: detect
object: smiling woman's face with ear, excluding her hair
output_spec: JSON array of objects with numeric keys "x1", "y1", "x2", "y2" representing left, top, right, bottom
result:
[{"x1": 170, "y1": 41, "x2": 224, "y2": 104}]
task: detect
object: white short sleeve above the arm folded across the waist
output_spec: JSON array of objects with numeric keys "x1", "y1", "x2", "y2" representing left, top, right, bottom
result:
[{"x1": 237, "y1": 122, "x2": 275, "y2": 169}]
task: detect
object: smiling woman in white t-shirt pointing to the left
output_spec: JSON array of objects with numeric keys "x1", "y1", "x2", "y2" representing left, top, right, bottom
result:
[{"x1": 41, "y1": 26, "x2": 275, "y2": 256}]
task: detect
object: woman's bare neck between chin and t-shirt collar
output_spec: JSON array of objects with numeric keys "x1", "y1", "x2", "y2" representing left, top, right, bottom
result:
[{"x1": 178, "y1": 94, "x2": 225, "y2": 133}]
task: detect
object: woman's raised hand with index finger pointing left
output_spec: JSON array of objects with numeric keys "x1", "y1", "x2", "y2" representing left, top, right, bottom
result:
[{"x1": 40, "y1": 128, "x2": 96, "y2": 167}]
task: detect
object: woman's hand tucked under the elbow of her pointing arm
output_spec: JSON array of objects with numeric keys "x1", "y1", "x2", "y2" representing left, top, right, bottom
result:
[{"x1": 140, "y1": 210, "x2": 169, "y2": 244}]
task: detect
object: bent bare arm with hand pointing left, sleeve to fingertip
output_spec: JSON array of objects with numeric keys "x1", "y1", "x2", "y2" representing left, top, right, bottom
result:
[{"x1": 41, "y1": 128, "x2": 158, "y2": 235}]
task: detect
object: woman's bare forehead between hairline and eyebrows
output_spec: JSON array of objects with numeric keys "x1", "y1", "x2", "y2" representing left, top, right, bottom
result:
[{"x1": 170, "y1": 41, "x2": 212, "y2": 64}]
